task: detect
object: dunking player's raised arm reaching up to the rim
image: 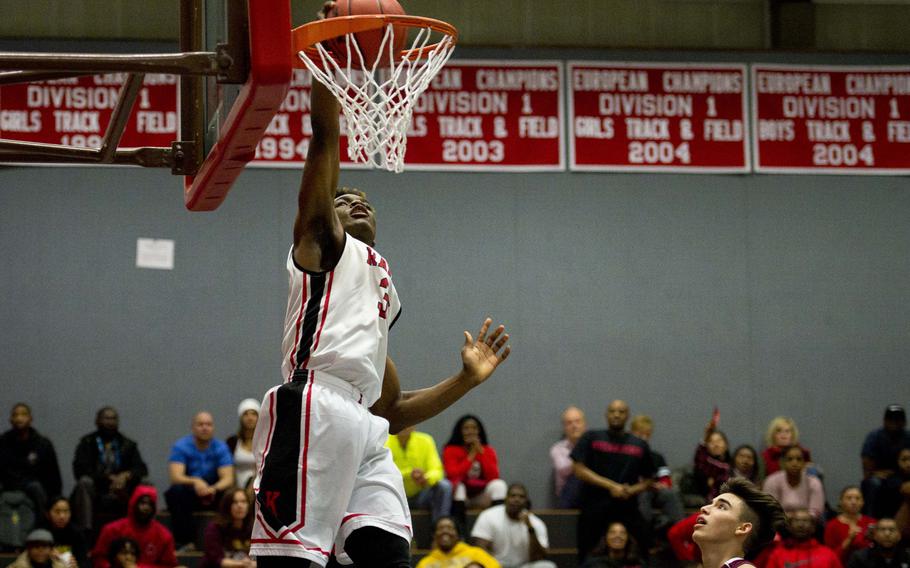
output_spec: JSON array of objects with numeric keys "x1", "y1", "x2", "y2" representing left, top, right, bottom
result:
[{"x1": 294, "y1": 76, "x2": 344, "y2": 272}]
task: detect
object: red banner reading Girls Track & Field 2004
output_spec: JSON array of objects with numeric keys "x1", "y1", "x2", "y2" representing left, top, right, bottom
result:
[{"x1": 568, "y1": 61, "x2": 750, "y2": 173}]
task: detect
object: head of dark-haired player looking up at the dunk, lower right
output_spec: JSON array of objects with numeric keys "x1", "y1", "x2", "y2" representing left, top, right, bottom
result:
[{"x1": 692, "y1": 478, "x2": 787, "y2": 568}]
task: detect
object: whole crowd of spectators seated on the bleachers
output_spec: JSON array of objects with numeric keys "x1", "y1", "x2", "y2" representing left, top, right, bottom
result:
[{"x1": 0, "y1": 399, "x2": 910, "y2": 568}]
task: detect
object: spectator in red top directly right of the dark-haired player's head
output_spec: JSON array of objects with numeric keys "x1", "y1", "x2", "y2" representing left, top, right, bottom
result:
[{"x1": 755, "y1": 509, "x2": 841, "y2": 568}]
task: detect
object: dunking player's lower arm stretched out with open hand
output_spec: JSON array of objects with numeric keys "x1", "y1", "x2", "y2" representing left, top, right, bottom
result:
[{"x1": 370, "y1": 318, "x2": 512, "y2": 434}]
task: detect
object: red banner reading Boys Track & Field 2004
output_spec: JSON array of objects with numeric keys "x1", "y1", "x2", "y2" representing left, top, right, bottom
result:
[{"x1": 752, "y1": 65, "x2": 910, "y2": 175}]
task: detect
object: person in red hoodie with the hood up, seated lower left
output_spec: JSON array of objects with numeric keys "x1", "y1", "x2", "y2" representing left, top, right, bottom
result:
[{"x1": 92, "y1": 485, "x2": 177, "y2": 568}]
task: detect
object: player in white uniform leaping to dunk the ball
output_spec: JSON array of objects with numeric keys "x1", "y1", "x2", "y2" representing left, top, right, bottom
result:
[{"x1": 251, "y1": 74, "x2": 510, "y2": 568}]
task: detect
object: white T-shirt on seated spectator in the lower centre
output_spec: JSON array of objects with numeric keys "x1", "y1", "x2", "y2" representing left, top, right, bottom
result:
[{"x1": 471, "y1": 505, "x2": 550, "y2": 568}]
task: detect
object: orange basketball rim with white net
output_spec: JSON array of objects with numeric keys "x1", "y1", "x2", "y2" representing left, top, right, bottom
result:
[{"x1": 292, "y1": 14, "x2": 458, "y2": 173}]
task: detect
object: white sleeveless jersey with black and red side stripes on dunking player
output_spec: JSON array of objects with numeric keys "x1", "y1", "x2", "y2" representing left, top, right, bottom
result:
[{"x1": 281, "y1": 235, "x2": 401, "y2": 407}]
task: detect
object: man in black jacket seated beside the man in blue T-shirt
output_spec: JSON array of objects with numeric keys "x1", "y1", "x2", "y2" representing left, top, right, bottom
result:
[{"x1": 72, "y1": 406, "x2": 148, "y2": 531}]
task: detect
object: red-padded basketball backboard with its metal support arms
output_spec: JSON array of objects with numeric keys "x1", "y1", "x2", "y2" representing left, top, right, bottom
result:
[{"x1": 0, "y1": 0, "x2": 291, "y2": 211}]
